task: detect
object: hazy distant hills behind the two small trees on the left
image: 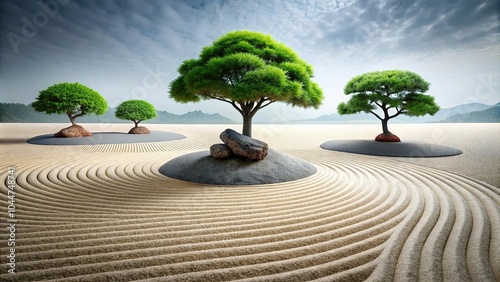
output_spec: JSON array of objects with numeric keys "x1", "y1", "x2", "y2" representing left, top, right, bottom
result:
[{"x1": 0, "y1": 103, "x2": 235, "y2": 124}]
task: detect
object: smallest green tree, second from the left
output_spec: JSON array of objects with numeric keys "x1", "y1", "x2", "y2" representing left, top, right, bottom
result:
[{"x1": 115, "y1": 100, "x2": 157, "y2": 127}]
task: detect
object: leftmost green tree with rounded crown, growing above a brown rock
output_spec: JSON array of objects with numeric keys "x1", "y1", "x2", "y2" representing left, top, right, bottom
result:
[{"x1": 31, "y1": 82, "x2": 108, "y2": 125}]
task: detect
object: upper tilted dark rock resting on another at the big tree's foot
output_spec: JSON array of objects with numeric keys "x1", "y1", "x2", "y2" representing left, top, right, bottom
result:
[{"x1": 220, "y1": 129, "x2": 268, "y2": 160}]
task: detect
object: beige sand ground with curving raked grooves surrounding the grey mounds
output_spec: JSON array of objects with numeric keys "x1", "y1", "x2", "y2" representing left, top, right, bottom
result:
[{"x1": 0, "y1": 124, "x2": 500, "y2": 281}]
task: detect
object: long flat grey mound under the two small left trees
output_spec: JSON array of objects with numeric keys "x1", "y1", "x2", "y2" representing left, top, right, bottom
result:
[{"x1": 26, "y1": 131, "x2": 186, "y2": 145}]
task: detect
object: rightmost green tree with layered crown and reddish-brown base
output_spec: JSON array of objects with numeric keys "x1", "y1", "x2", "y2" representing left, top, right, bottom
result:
[{"x1": 337, "y1": 70, "x2": 439, "y2": 142}]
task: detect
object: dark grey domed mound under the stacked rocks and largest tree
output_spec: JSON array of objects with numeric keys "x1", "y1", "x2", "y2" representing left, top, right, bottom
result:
[{"x1": 160, "y1": 149, "x2": 317, "y2": 185}]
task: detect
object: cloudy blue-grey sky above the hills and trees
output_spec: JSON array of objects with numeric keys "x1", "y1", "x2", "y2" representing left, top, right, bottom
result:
[{"x1": 0, "y1": 0, "x2": 500, "y2": 121}]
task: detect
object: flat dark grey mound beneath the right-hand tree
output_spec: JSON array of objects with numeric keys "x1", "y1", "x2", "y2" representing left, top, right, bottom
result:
[{"x1": 321, "y1": 140, "x2": 462, "y2": 158}]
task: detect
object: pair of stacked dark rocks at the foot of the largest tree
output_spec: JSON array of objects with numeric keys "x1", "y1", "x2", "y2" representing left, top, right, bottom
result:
[{"x1": 210, "y1": 129, "x2": 268, "y2": 160}]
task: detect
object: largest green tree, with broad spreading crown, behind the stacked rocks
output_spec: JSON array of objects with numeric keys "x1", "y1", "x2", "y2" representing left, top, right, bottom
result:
[{"x1": 170, "y1": 31, "x2": 323, "y2": 137}]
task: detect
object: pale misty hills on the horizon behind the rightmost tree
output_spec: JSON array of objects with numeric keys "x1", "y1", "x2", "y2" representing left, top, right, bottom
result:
[{"x1": 292, "y1": 103, "x2": 500, "y2": 124}]
